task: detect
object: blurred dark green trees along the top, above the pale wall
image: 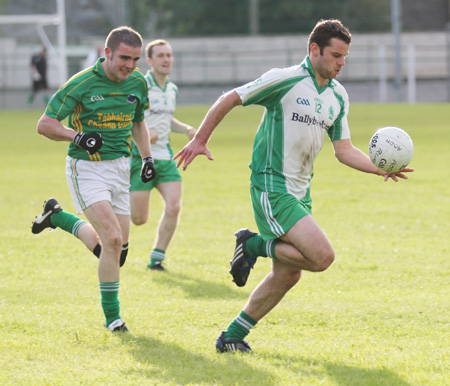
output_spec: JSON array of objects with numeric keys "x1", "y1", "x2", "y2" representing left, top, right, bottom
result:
[{"x1": 0, "y1": 0, "x2": 450, "y2": 40}]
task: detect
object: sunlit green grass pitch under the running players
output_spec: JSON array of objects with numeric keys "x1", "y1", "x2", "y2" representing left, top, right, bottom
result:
[{"x1": 0, "y1": 104, "x2": 450, "y2": 386}]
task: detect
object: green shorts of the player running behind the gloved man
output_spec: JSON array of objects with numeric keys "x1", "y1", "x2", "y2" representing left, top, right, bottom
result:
[{"x1": 130, "y1": 157, "x2": 181, "y2": 191}]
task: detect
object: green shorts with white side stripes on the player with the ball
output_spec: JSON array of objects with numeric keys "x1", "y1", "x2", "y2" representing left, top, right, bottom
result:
[{"x1": 250, "y1": 186, "x2": 312, "y2": 241}]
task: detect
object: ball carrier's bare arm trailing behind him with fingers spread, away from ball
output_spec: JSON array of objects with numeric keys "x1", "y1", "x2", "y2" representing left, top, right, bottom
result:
[{"x1": 173, "y1": 91, "x2": 242, "y2": 170}]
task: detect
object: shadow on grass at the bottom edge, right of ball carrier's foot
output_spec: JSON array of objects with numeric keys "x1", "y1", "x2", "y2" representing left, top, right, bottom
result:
[{"x1": 263, "y1": 354, "x2": 411, "y2": 386}]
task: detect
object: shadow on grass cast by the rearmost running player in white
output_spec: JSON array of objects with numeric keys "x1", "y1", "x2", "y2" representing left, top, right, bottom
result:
[{"x1": 152, "y1": 272, "x2": 249, "y2": 300}]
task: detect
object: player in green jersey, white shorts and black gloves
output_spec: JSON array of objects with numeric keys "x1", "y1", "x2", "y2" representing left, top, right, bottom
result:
[{"x1": 32, "y1": 27, "x2": 155, "y2": 332}]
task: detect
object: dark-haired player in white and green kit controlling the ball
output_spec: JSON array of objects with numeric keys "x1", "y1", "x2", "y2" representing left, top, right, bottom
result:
[{"x1": 175, "y1": 20, "x2": 413, "y2": 352}]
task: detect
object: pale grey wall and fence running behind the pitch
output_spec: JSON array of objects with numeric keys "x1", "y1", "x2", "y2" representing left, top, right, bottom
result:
[{"x1": 0, "y1": 32, "x2": 450, "y2": 109}]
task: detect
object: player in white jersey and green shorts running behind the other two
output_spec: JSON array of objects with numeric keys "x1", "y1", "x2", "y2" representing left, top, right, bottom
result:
[{"x1": 130, "y1": 39, "x2": 196, "y2": 270}]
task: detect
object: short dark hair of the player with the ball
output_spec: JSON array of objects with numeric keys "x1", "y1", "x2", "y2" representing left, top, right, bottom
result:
[{"x1": 308, "y1": 19, "x2": 352, "y2": 54}]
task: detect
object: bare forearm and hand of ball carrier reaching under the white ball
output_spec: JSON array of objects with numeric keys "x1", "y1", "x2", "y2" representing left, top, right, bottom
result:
[{"x1": 333, "y1": 139, "x2": 414, "y2": 182}]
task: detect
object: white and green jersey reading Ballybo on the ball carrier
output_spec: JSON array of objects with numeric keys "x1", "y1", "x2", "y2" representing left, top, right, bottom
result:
[{"x1": 235, "y1": 57, "x2": 350, "y2": 199}]
